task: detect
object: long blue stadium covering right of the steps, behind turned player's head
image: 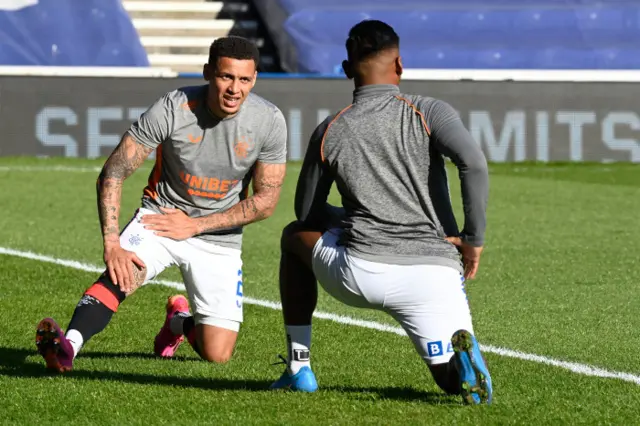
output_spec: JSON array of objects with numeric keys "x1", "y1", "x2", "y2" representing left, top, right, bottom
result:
[{"x1": 255, "y1": 0, "x2": 640, "y2": 74}]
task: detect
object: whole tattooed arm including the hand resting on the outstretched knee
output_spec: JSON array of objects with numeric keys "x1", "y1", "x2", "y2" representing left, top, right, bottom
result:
[{"x1": 96, "y1": 133, "x2": 153, "y2": 292}]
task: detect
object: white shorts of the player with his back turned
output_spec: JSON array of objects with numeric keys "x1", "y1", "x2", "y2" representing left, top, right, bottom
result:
[{"x1": 312, "y1": 229, "x2": 473, "y2": 365}]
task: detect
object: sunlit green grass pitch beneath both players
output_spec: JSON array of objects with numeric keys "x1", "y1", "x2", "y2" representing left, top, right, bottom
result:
[{"x1": 0, "y1": 158, "x2": 640, "y2": 425}]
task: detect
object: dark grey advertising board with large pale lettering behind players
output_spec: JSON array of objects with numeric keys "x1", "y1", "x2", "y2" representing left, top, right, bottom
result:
[{"x1": 0, "y1": 76, "x2": 640, "y2": 162}]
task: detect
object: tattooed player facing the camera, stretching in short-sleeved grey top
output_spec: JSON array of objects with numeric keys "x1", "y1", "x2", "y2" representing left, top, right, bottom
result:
[{"x1": 36, "y1": 37, "x2": 287, "y2": 372}]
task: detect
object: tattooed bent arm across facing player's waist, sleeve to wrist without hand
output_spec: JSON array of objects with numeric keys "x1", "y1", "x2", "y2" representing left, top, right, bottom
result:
[{"x1": 198, "y1": 163, "x2": 286, "y2": 233}]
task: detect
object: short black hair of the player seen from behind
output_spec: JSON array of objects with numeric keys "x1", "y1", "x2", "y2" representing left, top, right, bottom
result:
[{"x1": 346, "y1": 20, "x2": 400, "y2": 62}]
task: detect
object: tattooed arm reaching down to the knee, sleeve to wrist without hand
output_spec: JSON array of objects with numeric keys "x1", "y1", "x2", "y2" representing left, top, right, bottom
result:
[{"x1": 96, "y1": 134, "x2": 152, "y2": 245}]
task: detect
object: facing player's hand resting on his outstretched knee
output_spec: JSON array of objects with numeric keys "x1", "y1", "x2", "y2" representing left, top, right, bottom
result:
[{"x1": 104, "y1": 245, "x2": 146, "y2": 294}]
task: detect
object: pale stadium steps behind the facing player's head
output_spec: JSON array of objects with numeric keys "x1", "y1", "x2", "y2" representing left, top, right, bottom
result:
[{"x1": 122, "y1": 0, "x2": 277, "y2": 73}]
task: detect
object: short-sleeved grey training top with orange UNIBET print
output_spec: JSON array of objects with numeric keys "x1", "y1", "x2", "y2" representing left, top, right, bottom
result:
[{"x1": 129, "y1": 85, "x2": 287, "y2": 249}]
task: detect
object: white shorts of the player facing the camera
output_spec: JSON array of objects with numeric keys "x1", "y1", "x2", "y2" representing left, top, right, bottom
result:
[{"x1": 120, "y1": 208, "x2": 243, "y2": 331}]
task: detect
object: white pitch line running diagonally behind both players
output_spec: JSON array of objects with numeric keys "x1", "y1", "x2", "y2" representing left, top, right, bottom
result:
[{"x1": 0, "y1": 247, "x2": 640, "y2": 385}]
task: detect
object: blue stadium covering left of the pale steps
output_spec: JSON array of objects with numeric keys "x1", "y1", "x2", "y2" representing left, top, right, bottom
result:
[{"x1": 0, "y1": 0, "x2": 149, "y2": 67}]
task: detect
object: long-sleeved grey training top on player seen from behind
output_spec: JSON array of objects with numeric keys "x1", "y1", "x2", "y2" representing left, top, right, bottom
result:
[{"x1": 295, "y1": 85, "x2": 489, "y2": 271}]
